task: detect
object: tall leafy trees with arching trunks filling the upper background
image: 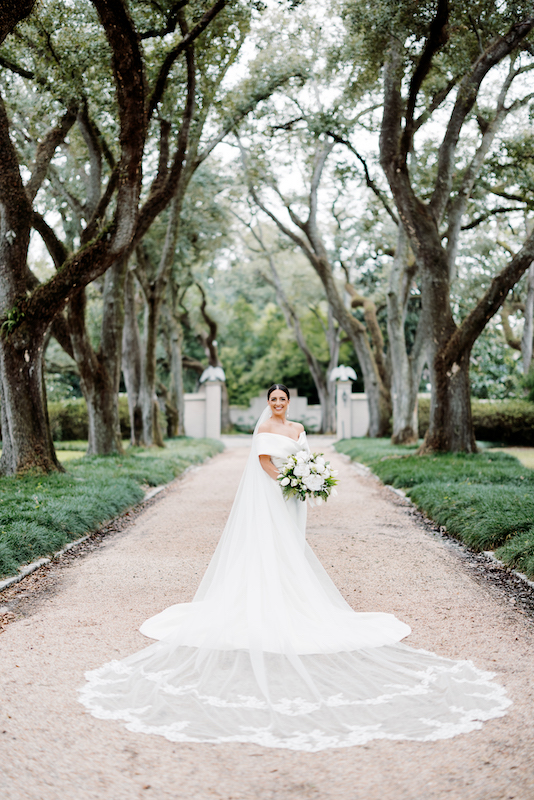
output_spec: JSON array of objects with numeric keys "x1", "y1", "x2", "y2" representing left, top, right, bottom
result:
[{"x1": 0, "y1": 0, "x2": 534, "y2": 474}]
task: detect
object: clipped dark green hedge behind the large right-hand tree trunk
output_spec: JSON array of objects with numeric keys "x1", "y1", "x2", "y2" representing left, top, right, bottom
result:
[{"x1": 419, "y1": 397, "x2": 534, "y2": 447}]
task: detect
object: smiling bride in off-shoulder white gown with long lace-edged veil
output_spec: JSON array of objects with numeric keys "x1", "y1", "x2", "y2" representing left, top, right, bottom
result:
[{"x1": 80, "y1": 384, "x2": 510, "y2": 751}]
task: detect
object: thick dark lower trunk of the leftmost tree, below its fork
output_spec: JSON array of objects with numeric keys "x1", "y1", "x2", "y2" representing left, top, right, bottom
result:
[{"x1": 0, "y1": 333, "x2": 63, "y2": 475}]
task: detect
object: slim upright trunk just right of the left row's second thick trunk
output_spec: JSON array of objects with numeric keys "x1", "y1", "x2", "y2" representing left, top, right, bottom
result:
[{"x1": 122, "y1": 272, "x2": 143, "y2": 447}]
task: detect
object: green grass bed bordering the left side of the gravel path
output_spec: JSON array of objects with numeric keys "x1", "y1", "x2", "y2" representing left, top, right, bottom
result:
[{"x1": 0, "y1": 438, "x2": 223, "y2": 577}]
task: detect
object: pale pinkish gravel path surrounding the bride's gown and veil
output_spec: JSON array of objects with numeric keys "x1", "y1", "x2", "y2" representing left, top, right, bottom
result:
[{"x1": 0, "y1": 439, "x2": 534, "y2": 800}]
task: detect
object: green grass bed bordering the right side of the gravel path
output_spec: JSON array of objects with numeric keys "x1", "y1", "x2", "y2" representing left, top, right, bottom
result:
[{"x1": 336, "y1": 439, "x2": 534, "y2": 578}]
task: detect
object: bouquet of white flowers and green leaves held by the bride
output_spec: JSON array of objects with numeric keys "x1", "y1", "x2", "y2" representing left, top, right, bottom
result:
[{"x1": 277, "y1": 450, "x2": 338, "y2": 505}]
